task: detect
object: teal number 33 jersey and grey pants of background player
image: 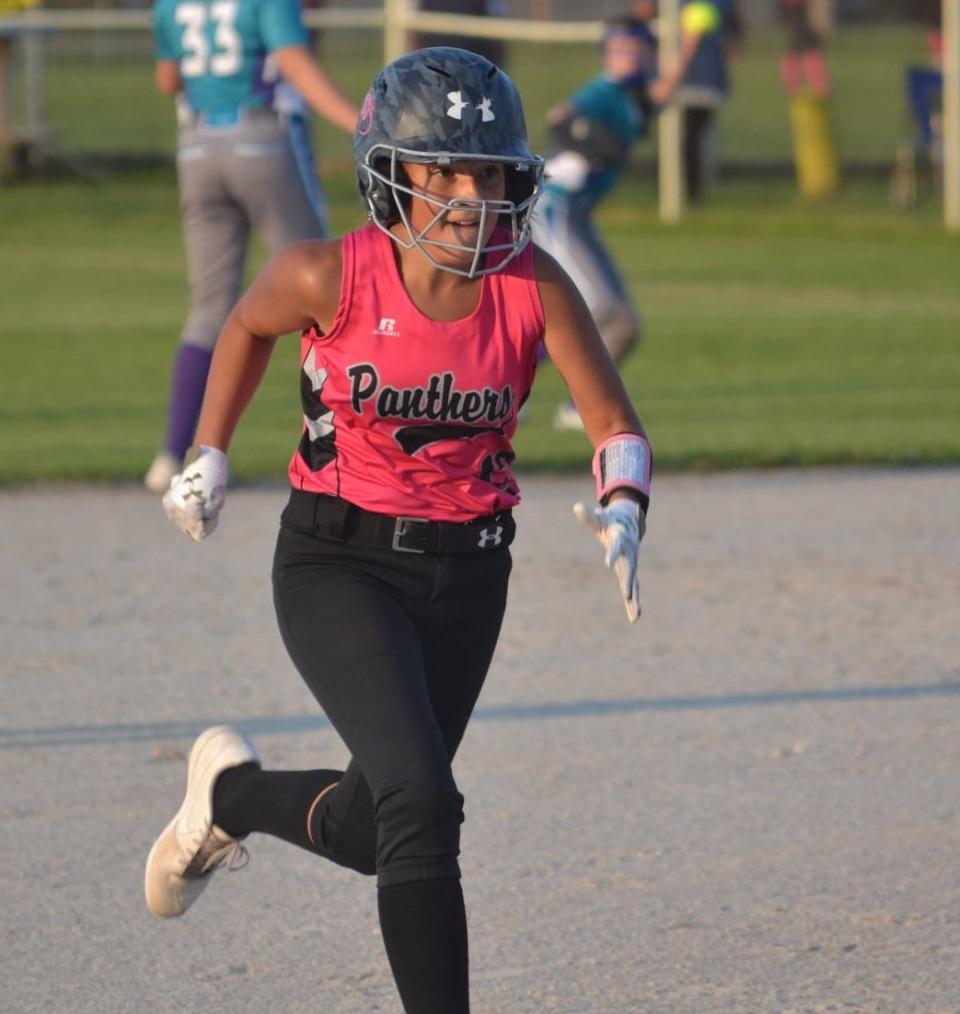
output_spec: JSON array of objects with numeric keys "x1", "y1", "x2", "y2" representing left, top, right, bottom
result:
[{"x1": 153, "y1": 0, "x2": 324, "y2": 352}]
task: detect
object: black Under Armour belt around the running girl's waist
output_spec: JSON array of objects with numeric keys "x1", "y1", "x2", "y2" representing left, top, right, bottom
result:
[{"x1": 281, "y1": 490, "x2": 517, "y2": 555}]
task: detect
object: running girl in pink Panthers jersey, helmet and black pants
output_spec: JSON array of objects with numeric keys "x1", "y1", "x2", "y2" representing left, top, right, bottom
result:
[{"x1": 145, "y1": 48, "x2": 650, "y2": 1014}]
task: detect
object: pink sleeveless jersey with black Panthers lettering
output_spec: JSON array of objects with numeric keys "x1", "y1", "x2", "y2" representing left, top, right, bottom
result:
[{"x1": 290, "y1": 225, "x2": 543, "y2": 521}]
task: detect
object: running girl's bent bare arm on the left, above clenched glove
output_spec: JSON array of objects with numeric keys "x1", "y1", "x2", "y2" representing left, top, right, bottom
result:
[{"x1": 197, "y1": 241, "x2": 342, "y2": 451}]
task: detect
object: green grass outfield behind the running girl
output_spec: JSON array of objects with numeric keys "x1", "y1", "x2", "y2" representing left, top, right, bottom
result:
[{"x1": 0, "y1": 29, "x2": 960, "y2": 483}]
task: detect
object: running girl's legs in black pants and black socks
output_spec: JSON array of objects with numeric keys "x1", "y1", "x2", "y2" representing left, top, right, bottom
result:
[{"x1": 242, "y1": 511, "x2": 511, "y2": 1014}]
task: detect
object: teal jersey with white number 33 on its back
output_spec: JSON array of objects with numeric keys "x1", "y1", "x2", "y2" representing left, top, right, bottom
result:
[{"x1": 153, "y1": 0, "x2": 307, "y2": 115}]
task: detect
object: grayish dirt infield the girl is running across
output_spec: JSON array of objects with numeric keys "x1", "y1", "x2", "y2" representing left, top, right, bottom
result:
[{"x1": 0, "y1": 469, "x2": 960, "y2": 1014}]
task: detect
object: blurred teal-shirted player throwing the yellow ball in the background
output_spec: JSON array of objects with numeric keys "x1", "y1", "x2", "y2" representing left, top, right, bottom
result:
[{"x1": 533, "y1": 15, "x2": 713, "y2": 430}]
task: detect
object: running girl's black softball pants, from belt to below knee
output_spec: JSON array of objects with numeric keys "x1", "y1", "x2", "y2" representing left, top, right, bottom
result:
[{"x1": 274, "y1": 515, "x2": 510, "y2": 886}]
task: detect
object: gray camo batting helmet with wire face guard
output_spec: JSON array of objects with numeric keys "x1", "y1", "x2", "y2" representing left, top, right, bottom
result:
[{"x1": 354, "y1": 46, "x2": 543, "y2": 278}]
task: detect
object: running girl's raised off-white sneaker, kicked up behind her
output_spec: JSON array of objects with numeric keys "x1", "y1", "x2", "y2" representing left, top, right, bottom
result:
[{"x1": 144, "y1": 725, "x2": 260, "y2": 918}]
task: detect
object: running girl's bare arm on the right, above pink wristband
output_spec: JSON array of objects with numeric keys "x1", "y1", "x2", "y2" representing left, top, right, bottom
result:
[{"x1": 535, "y1": 248, "x2": 646, "y2": 498}]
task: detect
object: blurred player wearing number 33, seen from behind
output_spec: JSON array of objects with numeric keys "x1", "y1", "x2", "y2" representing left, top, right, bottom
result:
[{"x1": 144, "y1": 0, "x2": 357, "y2": 492}]
